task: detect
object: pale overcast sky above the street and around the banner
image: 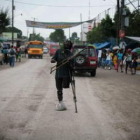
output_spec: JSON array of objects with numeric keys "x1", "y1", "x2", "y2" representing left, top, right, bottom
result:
[{"x1": 0, "y1": 0, "x2": 138, "y2": 38}]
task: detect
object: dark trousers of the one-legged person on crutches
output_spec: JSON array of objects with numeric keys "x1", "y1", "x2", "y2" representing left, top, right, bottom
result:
[{"x1": 55, "y1": 77, "x2": 70, "y2": 101}]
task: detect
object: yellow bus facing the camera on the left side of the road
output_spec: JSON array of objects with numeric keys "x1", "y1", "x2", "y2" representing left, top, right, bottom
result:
[{"x1": 27, "y1": 41, "x2": 43, "y2": 59}]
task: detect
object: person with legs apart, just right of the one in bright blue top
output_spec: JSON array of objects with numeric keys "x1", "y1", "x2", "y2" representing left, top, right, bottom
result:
[{"x1": 125, "y1": 49, "x2": 132, "y2": 74}]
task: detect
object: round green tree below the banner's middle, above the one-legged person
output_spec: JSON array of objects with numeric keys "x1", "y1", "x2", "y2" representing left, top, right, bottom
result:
[{"x1": 49, "y1": 29, "x2": 66, "y2": 43}]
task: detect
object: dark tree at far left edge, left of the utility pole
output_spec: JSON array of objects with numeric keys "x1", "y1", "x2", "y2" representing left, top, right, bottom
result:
[{"x1": 0, "y1": 8, "x2": 10, "y2": 33}]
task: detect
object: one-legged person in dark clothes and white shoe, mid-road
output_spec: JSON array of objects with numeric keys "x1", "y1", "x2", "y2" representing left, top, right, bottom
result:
[{"x1": 51, "y1": 40, "x2": 72, "y2": 111}]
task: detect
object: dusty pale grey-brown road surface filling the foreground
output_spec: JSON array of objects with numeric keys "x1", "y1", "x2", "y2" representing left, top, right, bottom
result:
[{"x1": 0, "y1": 54, "x2": 140, "y2": 140}]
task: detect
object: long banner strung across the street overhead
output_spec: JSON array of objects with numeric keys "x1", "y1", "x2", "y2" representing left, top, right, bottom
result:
[{"x1": 26, "y1": 20, "x2": 93, "y2": 29}]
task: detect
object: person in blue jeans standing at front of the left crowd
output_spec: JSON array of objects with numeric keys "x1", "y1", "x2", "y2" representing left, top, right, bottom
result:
[{"x1": 9, "y1": 45, "x2": 16, "y2": 67}]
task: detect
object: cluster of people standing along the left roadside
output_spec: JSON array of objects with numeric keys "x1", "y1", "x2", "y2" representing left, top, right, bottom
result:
[{"x1": 1, "y1": 45, "x2": 25, "y2": 67}]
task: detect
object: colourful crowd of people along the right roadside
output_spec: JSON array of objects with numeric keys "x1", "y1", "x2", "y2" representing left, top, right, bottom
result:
[{"x1": 98, "y1": 49, "x2": 140, "y2": 75}]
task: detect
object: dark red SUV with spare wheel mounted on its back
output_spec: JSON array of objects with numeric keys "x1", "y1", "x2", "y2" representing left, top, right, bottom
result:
[{"x1": 72, "y1": 45, "x2": 98, "y2": 77}]
